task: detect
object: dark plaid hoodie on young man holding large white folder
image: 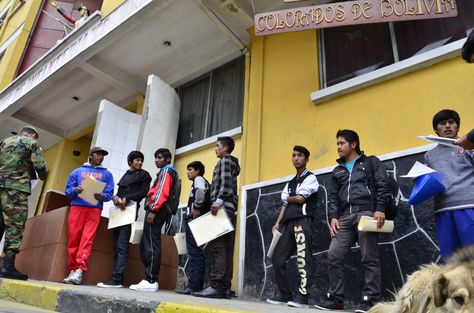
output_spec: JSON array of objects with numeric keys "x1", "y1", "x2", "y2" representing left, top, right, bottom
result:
[{"x1": 211, "y1": 154, "x2": 240, "y2": 210}]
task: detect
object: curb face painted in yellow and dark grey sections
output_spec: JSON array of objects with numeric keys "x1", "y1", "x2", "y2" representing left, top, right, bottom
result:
[{"x1": 0, "y1": 279, "x2": 256, "y2": 313}]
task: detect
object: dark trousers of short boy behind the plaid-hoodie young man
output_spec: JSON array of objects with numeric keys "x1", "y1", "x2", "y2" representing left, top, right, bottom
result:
[{"x1": 186, "y1": 219, "x2": 204, "y2": 291}]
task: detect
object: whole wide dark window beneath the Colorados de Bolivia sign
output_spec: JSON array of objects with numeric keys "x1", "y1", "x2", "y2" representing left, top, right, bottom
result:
[{"x1": 319, "y1": 0, "x2": 474, "y2": 88}]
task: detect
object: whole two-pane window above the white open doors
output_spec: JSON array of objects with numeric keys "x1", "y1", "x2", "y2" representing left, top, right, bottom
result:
[{"x1": 177, "y1": 57, "x2": 245, "y2": 148}]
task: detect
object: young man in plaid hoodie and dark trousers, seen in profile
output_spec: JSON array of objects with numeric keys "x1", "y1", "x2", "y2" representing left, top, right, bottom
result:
[{"x1": 192, "y1": 137, "x2": 240, "y2": 299}]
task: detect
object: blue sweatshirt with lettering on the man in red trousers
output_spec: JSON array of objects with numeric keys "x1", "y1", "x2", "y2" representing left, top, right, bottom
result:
[{"x1": 64, "y1": 163, "x2": 114, "y2": 209}]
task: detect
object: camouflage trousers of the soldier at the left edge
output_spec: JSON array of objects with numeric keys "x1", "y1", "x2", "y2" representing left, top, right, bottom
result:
[{"x1": 0, "y1": 188, "x2": 29, "y2": 255}]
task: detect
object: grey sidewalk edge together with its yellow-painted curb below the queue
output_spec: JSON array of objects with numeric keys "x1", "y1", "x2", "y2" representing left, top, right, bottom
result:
[{"x1": 0, "y1": 279, "x2": 350, "y2": 313}]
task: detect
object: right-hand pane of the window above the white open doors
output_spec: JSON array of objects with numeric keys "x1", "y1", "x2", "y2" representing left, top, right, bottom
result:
[{"x1": 208, "y1": 57, "x2": 245, "y2": 137}]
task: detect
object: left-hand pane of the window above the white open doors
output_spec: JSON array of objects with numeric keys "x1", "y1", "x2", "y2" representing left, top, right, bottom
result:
[{"x1": 177, "y1": 76, "x2": 210, "y2": 148}]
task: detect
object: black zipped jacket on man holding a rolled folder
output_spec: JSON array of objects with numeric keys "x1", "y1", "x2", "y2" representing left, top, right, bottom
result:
[{"x1": 328, "y1": 155, "x2": 391, "y2": 220}]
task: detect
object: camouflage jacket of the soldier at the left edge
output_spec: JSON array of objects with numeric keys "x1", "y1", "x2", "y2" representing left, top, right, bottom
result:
[{"x1": 0, "y1": 135, "x2": 46, "y2": 194}]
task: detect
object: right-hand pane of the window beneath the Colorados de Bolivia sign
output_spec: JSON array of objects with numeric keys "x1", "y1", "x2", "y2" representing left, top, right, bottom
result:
[{"x1": 395, "y1": 0, "x2": 474, "y2": 60}]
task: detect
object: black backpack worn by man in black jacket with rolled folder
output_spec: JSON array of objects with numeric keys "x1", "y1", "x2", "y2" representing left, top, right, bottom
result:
[{"x1": 365, "y1": 156, "x2": 398, "y2": 221}]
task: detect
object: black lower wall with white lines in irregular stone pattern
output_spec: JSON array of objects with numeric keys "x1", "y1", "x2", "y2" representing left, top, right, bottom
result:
[{"x1": 243, "y1": 153, "x2": 439, "y2": 307}]
